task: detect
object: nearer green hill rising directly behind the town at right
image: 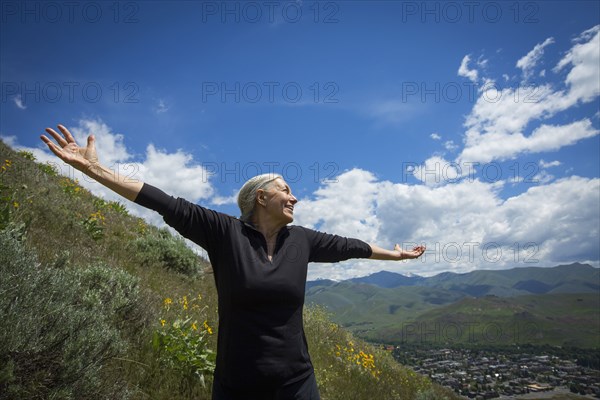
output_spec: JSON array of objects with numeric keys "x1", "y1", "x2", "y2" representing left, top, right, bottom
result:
[{"x1": 401, "y1": 293, "x2": 600, "y2": 348}]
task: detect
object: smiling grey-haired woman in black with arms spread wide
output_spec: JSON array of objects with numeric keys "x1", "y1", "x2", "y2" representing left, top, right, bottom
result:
[{"x1": 41, "y1": 125, "x2": 425, "y2": 400}]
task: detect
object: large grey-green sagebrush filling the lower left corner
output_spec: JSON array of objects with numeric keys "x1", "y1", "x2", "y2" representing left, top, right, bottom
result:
[{"x1": 0, "y1": 231, "x2": 141, "y2": 399}]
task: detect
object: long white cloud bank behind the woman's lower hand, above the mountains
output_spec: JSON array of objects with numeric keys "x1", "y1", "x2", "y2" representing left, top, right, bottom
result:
[{"x1": 297, "y1": 170, "x2": 600, "y2": 279}]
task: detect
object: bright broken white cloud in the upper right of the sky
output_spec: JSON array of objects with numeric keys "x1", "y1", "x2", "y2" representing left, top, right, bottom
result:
[{"x1": 458, "y1": 27, "x2": 600, "y2": 162}]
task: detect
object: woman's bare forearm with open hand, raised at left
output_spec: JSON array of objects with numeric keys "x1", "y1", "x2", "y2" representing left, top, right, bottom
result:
[{"x1": 40, "y1": 125, "x2": 144, "y2": 201}]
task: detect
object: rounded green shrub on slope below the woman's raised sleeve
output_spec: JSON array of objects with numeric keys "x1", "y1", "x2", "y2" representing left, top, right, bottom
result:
[{"x1": 130, "y1": 229, "x2": 201, "y2": 276}]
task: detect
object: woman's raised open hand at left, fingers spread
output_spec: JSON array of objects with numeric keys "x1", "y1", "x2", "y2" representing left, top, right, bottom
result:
[{"x1": 40, "y1": 125, "x2": 99, "y2": 173}]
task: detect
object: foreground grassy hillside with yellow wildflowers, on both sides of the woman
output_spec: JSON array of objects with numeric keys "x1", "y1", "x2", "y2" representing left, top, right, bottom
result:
[{"x1": 0, "y1": 142, "x2": 456, "y2": 400}]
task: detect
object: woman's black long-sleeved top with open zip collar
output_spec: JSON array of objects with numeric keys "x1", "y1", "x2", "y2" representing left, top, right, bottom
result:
[{"x1": 135, "y1": 184, "x2": 371, "y2": 390}]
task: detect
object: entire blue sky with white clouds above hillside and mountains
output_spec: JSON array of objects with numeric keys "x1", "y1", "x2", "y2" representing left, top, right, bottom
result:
[{"x1": 0, "y1": 1, "x2": 600, "y2": 279}]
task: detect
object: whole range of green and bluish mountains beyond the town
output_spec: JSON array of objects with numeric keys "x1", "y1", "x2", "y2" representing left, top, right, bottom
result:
[{"x1": 306, "y1": 263, "x2": 600, "y2": 347}]
